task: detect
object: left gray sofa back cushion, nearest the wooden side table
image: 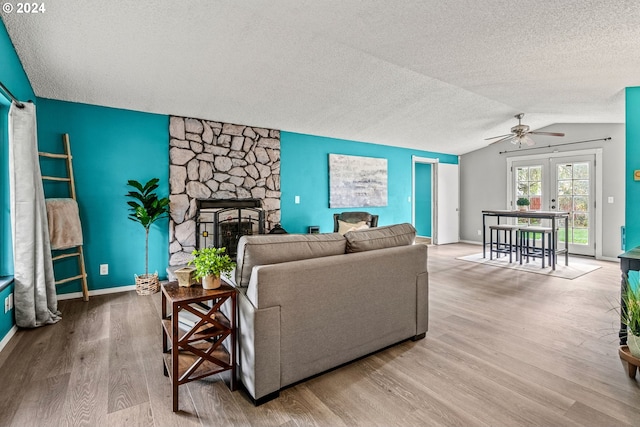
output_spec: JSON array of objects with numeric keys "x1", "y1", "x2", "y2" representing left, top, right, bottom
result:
[{"x1": 236, "y1": 233, "x2": 347, "y2": 286}]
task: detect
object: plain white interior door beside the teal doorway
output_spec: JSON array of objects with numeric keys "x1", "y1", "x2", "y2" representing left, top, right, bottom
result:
[{"x1": 433, "y1": 163, "x2": 460, "y2": 245}]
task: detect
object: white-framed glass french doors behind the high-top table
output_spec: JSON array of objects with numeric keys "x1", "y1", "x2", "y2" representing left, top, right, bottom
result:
[{"x1": 511, "y1": 154, "x2": 596, "y2": 256}]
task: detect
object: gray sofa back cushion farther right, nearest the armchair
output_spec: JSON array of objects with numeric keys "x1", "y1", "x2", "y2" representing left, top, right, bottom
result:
[{"x1": 344, "y1": 223, "x2": 416, "y2": 253}]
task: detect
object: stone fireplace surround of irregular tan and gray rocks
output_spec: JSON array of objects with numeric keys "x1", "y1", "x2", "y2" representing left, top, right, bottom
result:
[{"x1": 169, "y1": 116, "x2": 280, "y2": 266}]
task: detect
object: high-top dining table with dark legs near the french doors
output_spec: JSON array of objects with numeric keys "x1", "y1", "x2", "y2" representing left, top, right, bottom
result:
[{"x1": 482, "y1": 209, "x2": 569, "y2": 270}]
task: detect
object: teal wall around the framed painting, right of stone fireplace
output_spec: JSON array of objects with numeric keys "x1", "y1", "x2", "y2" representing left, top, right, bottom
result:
[{"x1": 280, "y1": 131, "x2": 458, "y2": 233}]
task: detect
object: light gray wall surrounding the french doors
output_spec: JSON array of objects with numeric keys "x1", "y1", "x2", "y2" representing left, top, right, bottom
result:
[{"x1": 460, "y1": 123, "x2": 625, "y2": 259}]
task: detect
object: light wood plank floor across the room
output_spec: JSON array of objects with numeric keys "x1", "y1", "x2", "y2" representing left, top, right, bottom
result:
[{"x1": 0, "y1": 244, "x2": 640, "y2": 426}]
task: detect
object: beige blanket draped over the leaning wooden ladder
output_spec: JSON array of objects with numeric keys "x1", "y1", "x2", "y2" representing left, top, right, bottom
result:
[{"x1": 45, "y1": 199, "x2": 83, "y2": 250}]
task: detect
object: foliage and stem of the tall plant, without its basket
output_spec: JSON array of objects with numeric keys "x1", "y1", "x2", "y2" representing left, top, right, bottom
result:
[{"x1": 127, "y1": 178, "x2": 169, "y2": 277}]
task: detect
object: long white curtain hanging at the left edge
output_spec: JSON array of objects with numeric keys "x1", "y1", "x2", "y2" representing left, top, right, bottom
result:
[{"x1": 9, "y1": 102, "x2": 61, "y2": 328}]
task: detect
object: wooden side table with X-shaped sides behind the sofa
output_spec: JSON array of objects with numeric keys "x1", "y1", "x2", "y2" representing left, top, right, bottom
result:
[{"x1": 162, "y1": 281, "x2": 237, "y2": 412}]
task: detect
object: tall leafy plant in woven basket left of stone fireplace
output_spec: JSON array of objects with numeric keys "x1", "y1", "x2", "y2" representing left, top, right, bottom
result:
[{"x1": 127, "y1": 178, "x2": 169, "y2": 295}]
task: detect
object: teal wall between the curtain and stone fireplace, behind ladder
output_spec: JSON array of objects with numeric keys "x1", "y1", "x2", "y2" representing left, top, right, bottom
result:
[{"x1": 37, "y1": 98, "x2": 169, "y2": 294}]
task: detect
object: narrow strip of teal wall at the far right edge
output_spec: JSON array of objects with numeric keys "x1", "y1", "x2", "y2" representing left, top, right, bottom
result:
[{"x1": 625, "y1": 87, "x2": 640, "y2": 250}]
